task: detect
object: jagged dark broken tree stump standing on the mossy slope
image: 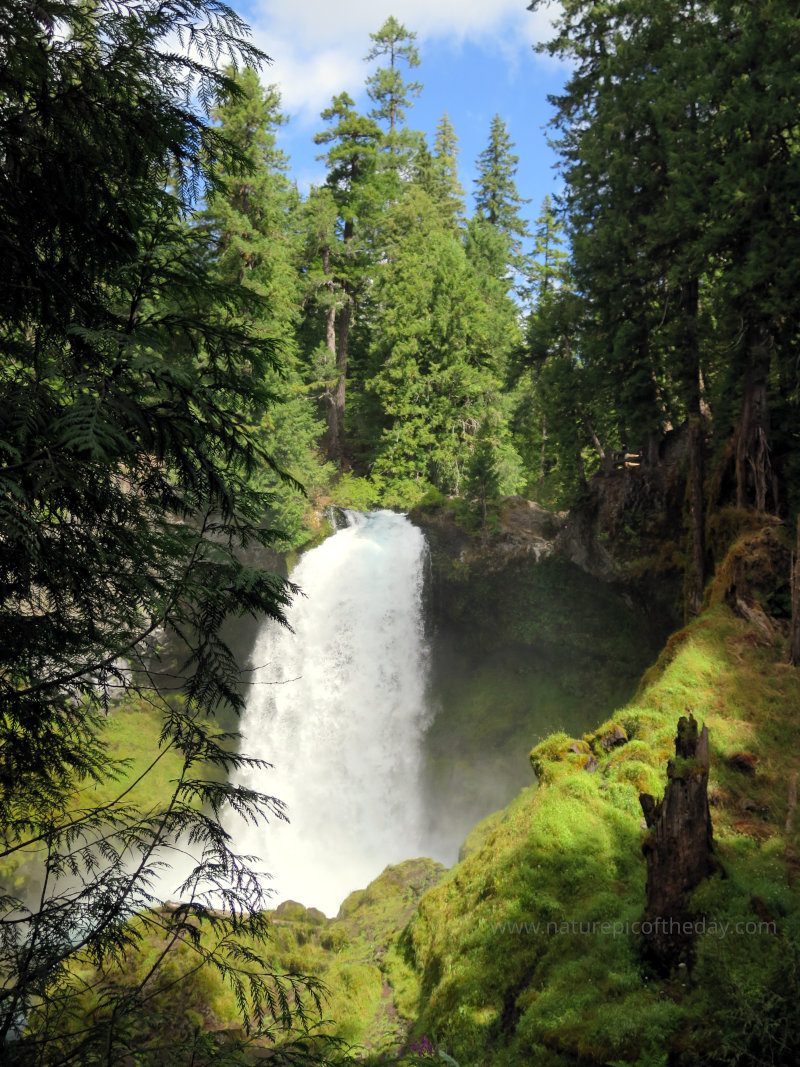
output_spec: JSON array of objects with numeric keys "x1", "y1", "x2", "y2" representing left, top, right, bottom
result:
[{"x1": 639, "y1": 715, "x2": 715, "y2": 973}]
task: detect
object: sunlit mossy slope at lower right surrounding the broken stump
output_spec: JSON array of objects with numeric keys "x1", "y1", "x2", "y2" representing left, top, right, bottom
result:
[{"x1": 403, "y1": 598, "x2": 800, "y2": 1067}]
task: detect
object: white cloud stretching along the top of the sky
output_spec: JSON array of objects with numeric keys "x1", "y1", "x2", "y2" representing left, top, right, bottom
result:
[{"x1": 245, "y1": 0, "x2": 556, "y2": 123}]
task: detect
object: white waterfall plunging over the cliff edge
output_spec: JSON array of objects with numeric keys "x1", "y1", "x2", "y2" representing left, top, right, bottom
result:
[{"x1": 230, "y1": 511, "x2": 428, "y2": 915}]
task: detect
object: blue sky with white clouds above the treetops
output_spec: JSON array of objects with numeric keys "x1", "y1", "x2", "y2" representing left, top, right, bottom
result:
[{"x1": 236, "y1": 0, "x2": 566, "y2": 240}]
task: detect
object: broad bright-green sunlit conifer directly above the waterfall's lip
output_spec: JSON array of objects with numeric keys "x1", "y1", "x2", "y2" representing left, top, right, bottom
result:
[{"x1": 367, "y1": 188, "x2": 498, "y2": 504}]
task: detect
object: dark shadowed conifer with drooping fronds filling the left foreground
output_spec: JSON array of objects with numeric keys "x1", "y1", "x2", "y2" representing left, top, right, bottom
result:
[{"x1": 0, "y1": 0, "x2": 326, "y2": 1065}]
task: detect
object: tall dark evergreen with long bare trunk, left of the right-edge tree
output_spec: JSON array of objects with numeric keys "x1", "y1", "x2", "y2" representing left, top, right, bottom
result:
[{"x1": 533, "y1": 0, "x2": 708, "y2": 609}]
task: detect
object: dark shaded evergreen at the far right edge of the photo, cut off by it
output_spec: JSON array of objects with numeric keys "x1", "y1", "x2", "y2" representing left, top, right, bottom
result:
[{"x1": 708, "y1": 0, "x2": 800, "y2": 511}]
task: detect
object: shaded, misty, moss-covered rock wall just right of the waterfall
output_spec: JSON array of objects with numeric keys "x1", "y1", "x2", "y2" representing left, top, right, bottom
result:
[{"x1": 425, "y1": 550, "x2": 656, "y2": 840}]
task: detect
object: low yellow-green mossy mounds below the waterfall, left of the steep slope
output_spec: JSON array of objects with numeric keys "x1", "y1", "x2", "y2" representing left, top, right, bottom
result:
[{"x1": 45, "y1": 859, "x2": 446, "y2": 1067}]
